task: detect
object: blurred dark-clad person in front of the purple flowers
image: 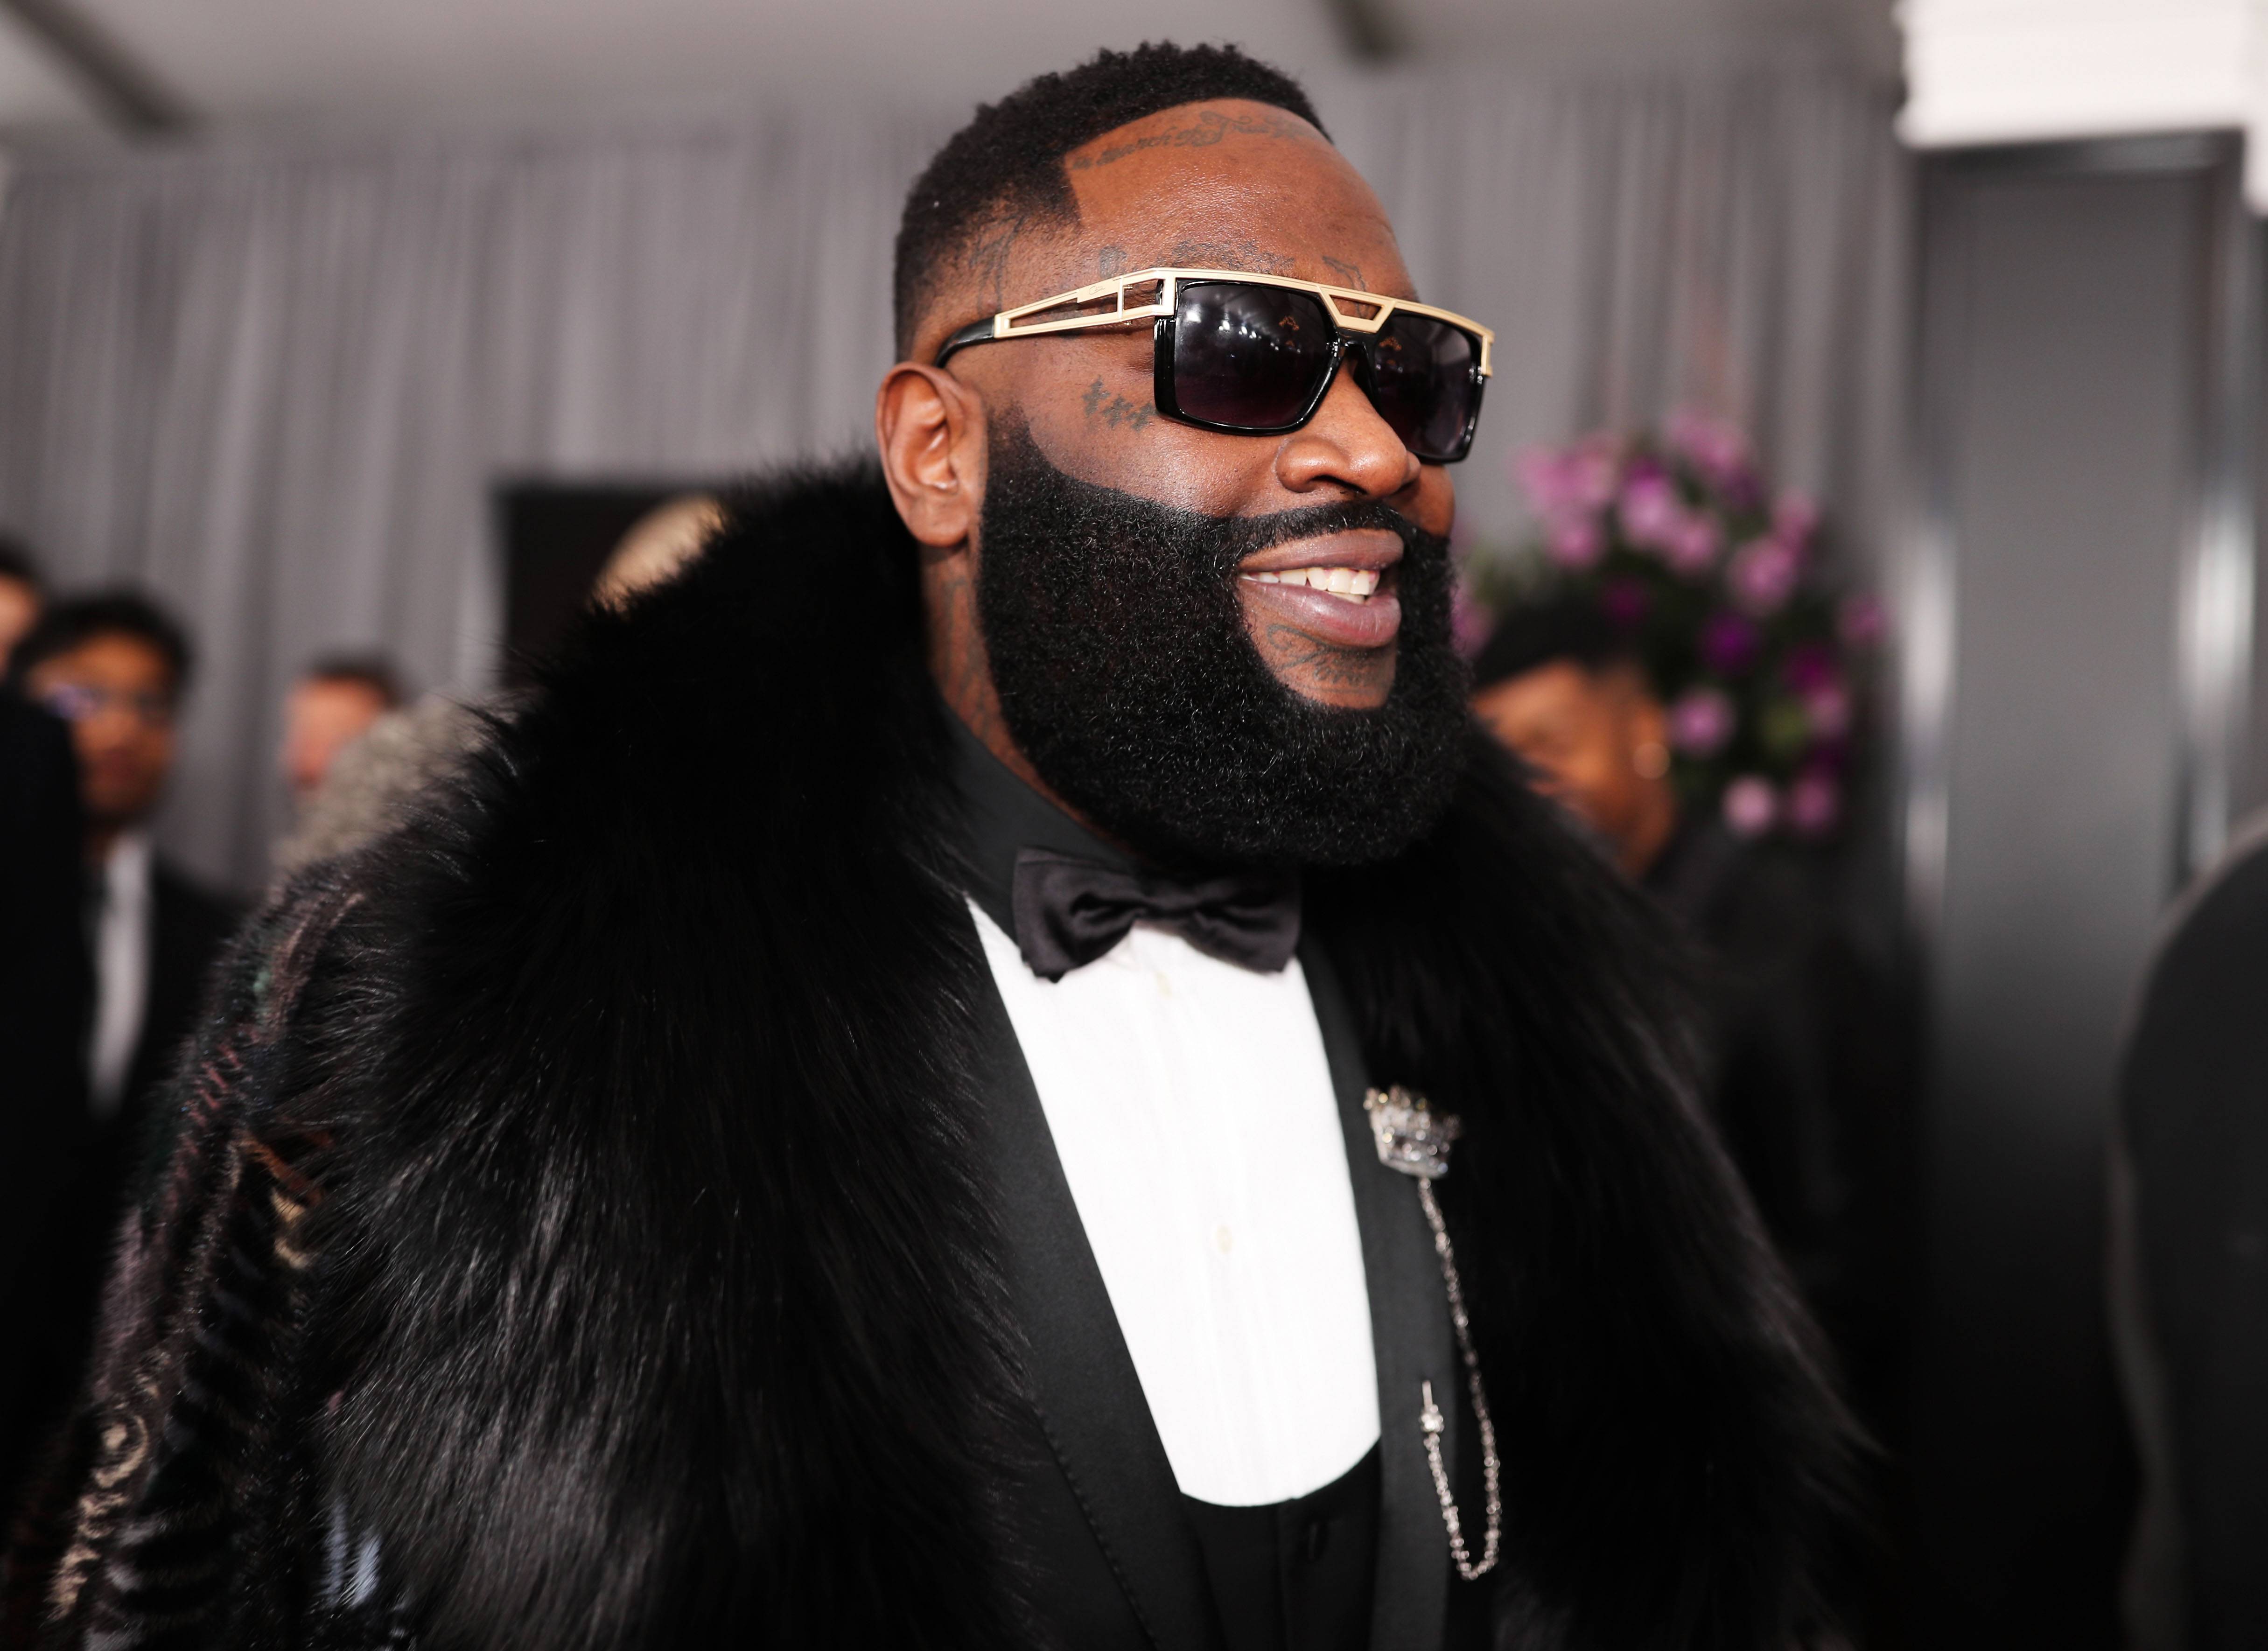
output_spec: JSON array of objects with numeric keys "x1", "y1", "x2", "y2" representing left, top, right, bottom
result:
[{"x1": 1472, "y1": 594, "x2": 1917, "y2": 1431}]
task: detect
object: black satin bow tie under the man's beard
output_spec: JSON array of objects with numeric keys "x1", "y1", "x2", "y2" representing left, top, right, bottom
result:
[{"x1": 1014, "y1": 848, "x2": 1300, "y2": 979}]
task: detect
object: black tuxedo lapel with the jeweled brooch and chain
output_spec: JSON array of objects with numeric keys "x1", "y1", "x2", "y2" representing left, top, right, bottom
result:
[{"x1": 1300, "y1": 941, "x2": 1461, "y2": 1651}]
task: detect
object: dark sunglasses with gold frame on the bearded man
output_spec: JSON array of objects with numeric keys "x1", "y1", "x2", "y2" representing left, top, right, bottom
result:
[{"x1": 934, "y1": 270, "x2": 1497, "y2": 465}]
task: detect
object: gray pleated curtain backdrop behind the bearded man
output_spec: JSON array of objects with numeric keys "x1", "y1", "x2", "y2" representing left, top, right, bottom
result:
[{"x1": 0, "y1": 68, "x2": 1910, "y2": 887}]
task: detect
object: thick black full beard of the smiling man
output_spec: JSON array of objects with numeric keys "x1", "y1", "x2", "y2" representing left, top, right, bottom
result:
[{"x1": 978, "y1": 427, "x2": 1467, "y2": 866}]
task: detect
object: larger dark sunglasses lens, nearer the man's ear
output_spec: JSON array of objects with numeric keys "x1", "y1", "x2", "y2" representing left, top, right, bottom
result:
[{"x1": 1173, "y1": 281, "x2": 1336, "y2": 431}]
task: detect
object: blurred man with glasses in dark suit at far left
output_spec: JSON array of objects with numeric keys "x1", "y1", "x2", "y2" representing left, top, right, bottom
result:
[{"x1": 0, "y1": 592, "x2": 238, "y2": 1524}]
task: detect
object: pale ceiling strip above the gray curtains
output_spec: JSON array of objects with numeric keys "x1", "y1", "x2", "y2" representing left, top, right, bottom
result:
[{"x1": 0, "y1": 0, "x2": 1896, "y2": 129}]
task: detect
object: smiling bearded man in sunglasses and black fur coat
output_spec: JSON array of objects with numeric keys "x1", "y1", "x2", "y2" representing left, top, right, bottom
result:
[{"x1": 18, "y1": 48, "x2": 1846, "y2": 1651}]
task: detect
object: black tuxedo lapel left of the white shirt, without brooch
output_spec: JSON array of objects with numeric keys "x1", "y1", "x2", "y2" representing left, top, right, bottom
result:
[{"x1": 971, "y1": 941, "x2": 1216, "y2": 1651}]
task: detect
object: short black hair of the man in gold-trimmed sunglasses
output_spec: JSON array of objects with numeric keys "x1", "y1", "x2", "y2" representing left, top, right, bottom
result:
[{"x1": 891, "y1": 41, "x2": 1329, "y2": 356}]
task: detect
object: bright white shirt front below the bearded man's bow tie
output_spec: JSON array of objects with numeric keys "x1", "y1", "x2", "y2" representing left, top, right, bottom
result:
[{"x1": 971, "y1": 902, "x2": 1379, "y2": 1506}]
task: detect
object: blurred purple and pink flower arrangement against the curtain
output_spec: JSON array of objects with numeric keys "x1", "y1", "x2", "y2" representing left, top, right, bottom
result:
[{"x1": 1488, "y1": 415, "x2": 1883, "y2": 841}]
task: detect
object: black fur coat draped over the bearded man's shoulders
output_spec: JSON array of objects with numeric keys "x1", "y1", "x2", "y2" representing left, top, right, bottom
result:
[{"x1": 9, "y1": 460, "x2": 1846, "y2": 1651}]
